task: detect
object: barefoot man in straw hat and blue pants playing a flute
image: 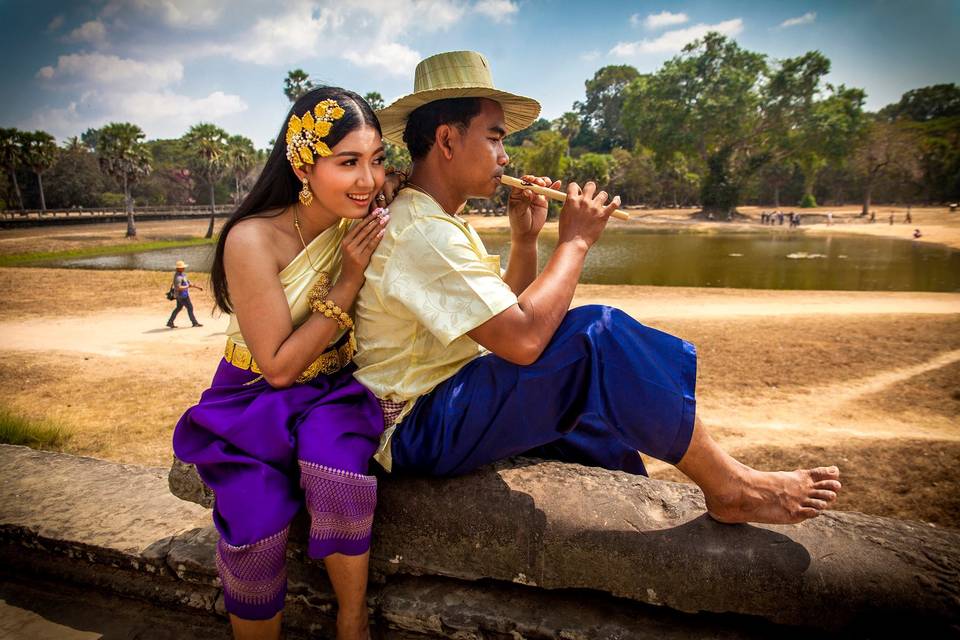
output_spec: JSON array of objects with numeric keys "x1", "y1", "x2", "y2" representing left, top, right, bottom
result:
[{"x1": 355, "y1": 51, "x2": 840, "y2": 523}]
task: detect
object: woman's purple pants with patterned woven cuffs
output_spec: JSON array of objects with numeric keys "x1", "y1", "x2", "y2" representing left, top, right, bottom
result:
[{"x1": 173, "y1": 360, "x2": 383, "y2": 620}]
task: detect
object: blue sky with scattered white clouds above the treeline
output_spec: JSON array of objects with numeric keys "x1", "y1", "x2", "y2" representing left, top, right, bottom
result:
[{"x1": 0, "y1": 0, "x2": 960, "y2": 147}]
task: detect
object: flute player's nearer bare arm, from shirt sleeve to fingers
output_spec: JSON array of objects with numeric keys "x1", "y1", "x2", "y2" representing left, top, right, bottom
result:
[{"x1": 467, "y1": 182, "x2": 620, "y2": 365}]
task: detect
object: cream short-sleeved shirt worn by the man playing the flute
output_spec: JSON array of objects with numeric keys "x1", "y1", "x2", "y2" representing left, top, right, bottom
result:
[{"x1": 354, "y1": 188, "x2": 517, "y2": 471}]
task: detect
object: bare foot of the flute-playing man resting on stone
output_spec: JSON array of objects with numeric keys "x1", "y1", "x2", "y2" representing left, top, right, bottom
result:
[{"x1": 704, "y1": 463, "x2": 841, "y2": 524}]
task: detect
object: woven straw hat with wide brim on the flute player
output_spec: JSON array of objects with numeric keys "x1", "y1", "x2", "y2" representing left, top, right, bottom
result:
[{"x1": 377, "y1": 51, "x2": 540, "y2": 145}]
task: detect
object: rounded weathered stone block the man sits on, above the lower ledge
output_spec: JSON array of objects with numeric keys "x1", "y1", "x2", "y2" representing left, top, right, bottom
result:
[{"x1": 171, "y1": 459, "x2": 960, "y2": 631}]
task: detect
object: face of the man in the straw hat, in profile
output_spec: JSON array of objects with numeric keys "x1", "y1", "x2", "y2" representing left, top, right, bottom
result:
[{"x1": 452, "y1": 99, "x2": 510, "y2": 198}]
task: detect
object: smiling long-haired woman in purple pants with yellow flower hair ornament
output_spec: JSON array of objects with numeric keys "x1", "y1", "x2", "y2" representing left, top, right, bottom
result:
[{"x1": 173, "y1": 87, "x2": 389, "y2": 638}]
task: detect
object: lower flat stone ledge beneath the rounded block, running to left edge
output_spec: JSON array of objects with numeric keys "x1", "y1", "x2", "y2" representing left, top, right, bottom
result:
[{"x1": 0, "y1": 445, "x2": 812, "y2": 640}]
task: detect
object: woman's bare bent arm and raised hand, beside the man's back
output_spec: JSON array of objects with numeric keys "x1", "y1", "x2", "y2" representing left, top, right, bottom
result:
[{"x1": 224, "y1": 215, "x2": 386, "y2": 388}]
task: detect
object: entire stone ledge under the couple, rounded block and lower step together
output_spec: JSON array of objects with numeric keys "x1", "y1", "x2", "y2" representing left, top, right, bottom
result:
[{"x1": 0, "y1": 446, "x2": 960, "y2": 639}]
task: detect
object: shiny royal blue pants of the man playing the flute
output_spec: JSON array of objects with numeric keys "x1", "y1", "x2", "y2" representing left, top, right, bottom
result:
[{"x1": 391, "y1": 306, "x2": 697, "y2": 476}]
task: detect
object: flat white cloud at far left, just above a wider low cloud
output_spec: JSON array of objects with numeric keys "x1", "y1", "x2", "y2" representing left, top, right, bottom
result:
[{"x1": 37, "y1": 53, "x2": 183, "y2": 89}]
